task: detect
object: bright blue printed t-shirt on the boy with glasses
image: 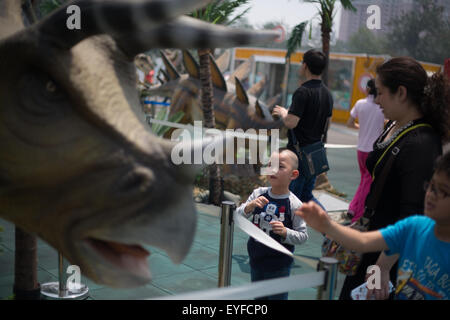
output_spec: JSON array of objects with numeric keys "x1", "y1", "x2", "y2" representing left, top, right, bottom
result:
[{"x1": 380, "y1": 216, "x2": 450, "y2": 300}]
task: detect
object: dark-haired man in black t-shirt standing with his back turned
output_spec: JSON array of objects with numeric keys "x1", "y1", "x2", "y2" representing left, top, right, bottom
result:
[{"x1": 273, "y1": 49, "x2": 333, "y2": 206}]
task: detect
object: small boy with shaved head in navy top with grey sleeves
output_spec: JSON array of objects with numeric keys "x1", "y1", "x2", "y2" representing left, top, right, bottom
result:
[{"x1": 236, "y1": 149, "x2": 308, "y2": 300}]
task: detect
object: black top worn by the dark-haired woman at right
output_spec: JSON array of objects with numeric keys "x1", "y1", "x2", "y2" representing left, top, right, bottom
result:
[{"x1": 366, "y1": 119, "x2": 442, "y2": 230}]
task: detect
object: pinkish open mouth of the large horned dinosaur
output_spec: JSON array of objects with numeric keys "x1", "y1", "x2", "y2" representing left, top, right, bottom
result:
[{"x1": 86, "y1": 238, "x2": 150, "y2": 278}]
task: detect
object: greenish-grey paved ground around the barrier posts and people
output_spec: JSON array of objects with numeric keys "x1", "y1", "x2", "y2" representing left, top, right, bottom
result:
[{"x1": 0, "y1": 125, "x2": 359, "y2": 300}]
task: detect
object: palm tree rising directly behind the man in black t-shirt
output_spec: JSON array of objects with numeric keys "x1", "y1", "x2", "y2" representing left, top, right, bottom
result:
[{"x1": 305, "y1": 0, "x2": 356, "y2": 85}]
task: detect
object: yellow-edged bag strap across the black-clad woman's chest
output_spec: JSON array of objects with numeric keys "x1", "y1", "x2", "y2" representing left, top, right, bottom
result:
[{"x1": 362, "y1": 123, "x2": 431, "y2": 221}]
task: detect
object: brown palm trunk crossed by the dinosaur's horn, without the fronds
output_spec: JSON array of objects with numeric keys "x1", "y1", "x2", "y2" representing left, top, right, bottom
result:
[{"x1": 198, "y1": 49, "x2": 223, "y2": 205}]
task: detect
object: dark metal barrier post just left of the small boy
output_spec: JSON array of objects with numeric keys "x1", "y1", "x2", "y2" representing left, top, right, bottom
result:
[{"x1": 219, "y1": 201, "x2": 236, "y2": 287}]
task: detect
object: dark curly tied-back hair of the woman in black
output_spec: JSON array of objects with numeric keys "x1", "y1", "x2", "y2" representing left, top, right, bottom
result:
[{"x1": 377, "y1": 57, "x2": 450, "y2": 140}]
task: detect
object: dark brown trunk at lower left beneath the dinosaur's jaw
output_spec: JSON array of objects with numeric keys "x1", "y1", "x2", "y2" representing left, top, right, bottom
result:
[{"x1": 13, "y1": 227, "x2": 40, "y2": 300}]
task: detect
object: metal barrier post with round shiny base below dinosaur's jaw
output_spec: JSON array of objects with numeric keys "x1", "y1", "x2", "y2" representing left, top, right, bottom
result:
[{"x1": 41, "y1": 253, "x2": 89, "y2": 300}]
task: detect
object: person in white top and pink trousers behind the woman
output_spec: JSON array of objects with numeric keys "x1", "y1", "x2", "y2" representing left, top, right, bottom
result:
[{"x1": 347, "y1": 79, "x2": 384, "y2": 222}]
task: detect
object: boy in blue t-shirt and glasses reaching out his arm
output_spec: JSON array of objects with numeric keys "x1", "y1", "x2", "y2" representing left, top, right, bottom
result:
[{"x1": 295, "y1": 152, "x2": 450, "y2": 300}]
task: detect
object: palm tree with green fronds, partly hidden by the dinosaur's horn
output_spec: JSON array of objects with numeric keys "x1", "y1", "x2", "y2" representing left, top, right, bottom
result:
[{"x1": 190, "y1": 0, "x2": 250, "y2": 205}]
